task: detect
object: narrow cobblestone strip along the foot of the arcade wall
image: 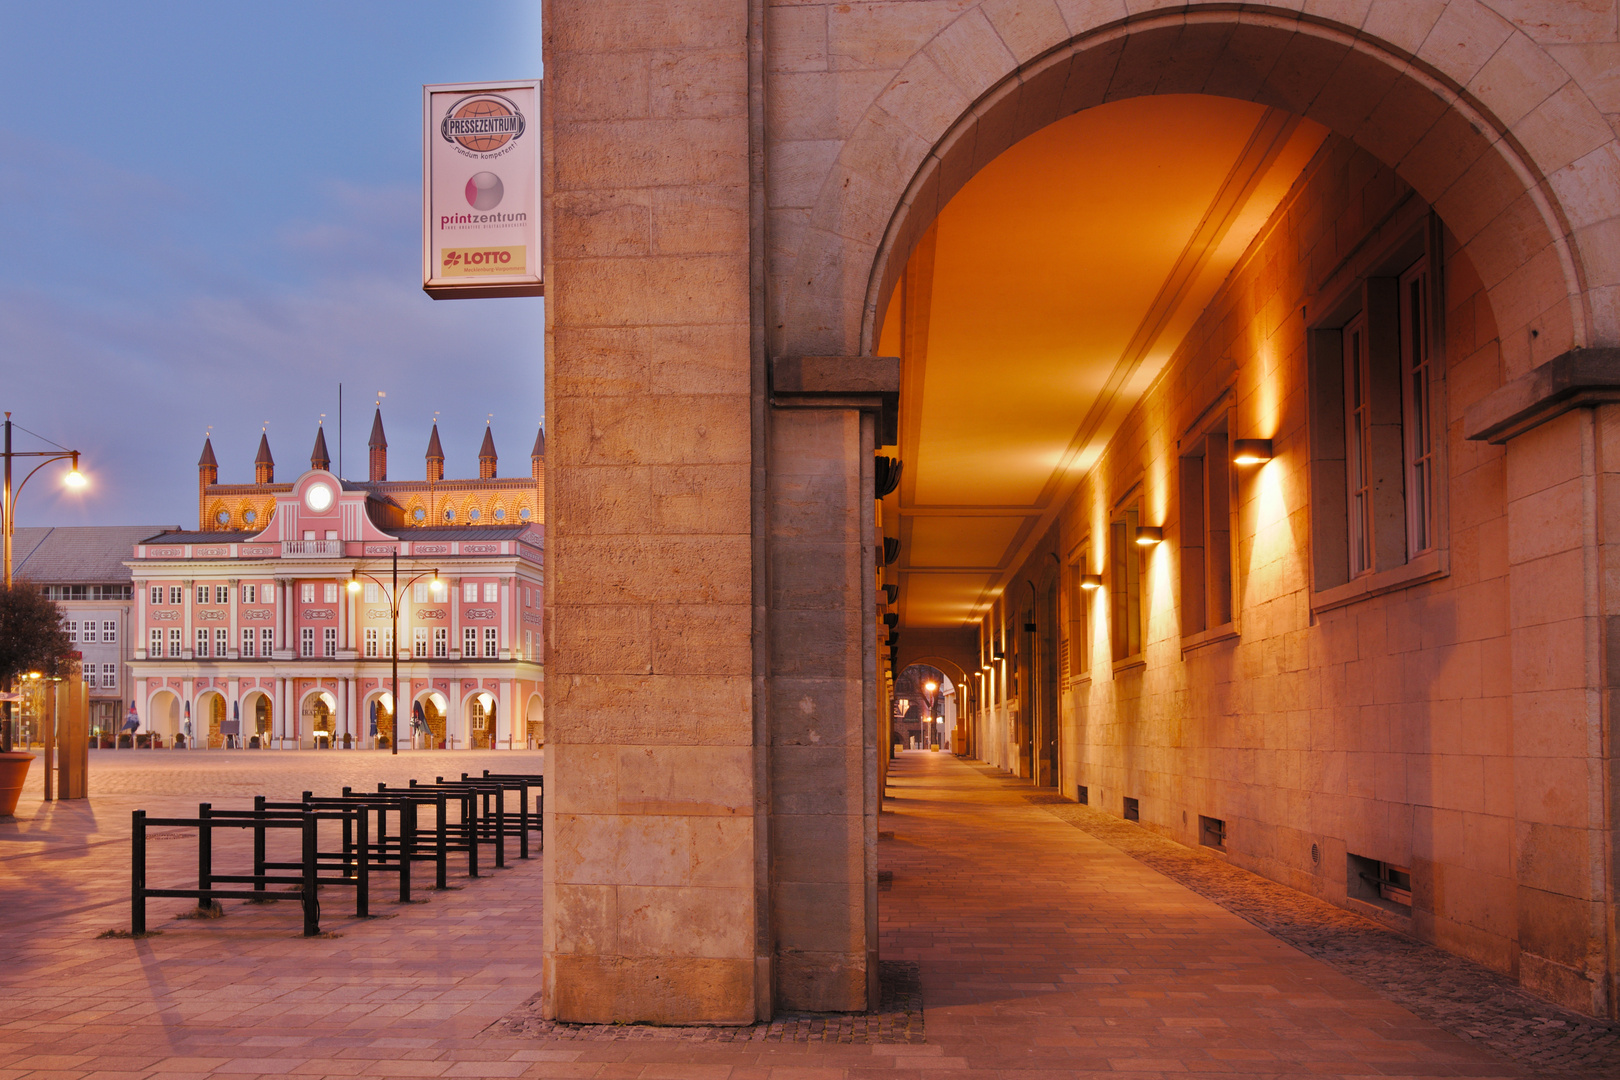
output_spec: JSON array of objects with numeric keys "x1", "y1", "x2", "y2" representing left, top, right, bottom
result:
[{"x1": 1010, "y1": 767, "x2": 1620, "y2": 1078}]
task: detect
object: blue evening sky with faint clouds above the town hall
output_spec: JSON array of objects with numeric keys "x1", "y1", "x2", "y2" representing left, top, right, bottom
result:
[{"x1": 0, "y1": 0, "x2": 544, "y2": 528}]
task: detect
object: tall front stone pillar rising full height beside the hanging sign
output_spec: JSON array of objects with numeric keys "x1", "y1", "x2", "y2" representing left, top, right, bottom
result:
[{"x1": 544, "y1": 0, "x2": 751, "y2": 1023}]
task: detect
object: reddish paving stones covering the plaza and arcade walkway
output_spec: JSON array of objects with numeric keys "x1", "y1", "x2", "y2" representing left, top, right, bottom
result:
[{"x1": 0, "y1": 751, "x2": 1620, "y2": 1080}]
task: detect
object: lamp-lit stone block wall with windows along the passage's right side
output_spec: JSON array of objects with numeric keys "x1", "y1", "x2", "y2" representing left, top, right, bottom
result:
[{"x1": 982, "y1": 138, "x2": 1620, "y2": 1012}]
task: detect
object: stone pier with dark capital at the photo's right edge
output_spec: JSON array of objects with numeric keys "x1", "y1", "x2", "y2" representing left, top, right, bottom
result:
[{"x1": 1453, "y1": 348, "x2": 1620, "y2": 1015}]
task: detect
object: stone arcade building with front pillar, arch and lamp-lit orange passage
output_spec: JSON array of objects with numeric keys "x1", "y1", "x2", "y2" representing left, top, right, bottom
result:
[{"x1": 544, "y1": 0, "x2": 1620, "y2": 1022}]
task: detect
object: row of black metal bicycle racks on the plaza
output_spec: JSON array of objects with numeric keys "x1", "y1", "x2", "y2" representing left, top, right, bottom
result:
[{"x1": 130, "y1": 769, "x2": 546, "y2": 938}]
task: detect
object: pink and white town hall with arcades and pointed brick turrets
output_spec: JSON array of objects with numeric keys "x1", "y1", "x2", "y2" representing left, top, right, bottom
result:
[{"x1": 128, "y1": 413, "x2": 544, "y2": 748}]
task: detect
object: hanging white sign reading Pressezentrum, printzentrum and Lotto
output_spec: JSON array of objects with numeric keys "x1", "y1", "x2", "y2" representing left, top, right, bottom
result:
[{"x1": 421, "y1": 79, "x2": 544, "y2": 300}]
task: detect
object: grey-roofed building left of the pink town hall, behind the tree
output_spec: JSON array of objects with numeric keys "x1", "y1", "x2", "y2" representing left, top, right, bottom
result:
[{"x1": 11, "y1": 525, "x2": 174, "y2": 735}]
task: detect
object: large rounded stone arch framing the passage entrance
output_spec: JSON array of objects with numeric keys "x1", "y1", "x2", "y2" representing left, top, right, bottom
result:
[{"x1": 773, "y1": 0, "x2": 1620, "y2": 377}]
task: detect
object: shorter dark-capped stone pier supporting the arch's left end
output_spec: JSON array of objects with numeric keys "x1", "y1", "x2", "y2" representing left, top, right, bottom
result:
[{"x1": 766, "y1": 356, "x2": 901, "y2": 1010}]
